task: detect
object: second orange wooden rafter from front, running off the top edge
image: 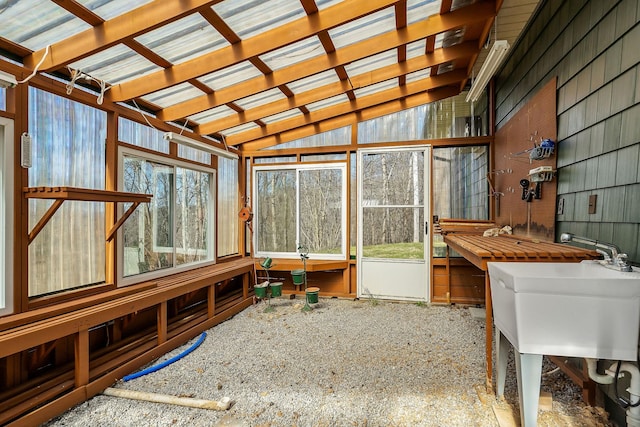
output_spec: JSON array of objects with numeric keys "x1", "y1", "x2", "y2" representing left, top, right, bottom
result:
[{"x1": 105, "y1": 0, "x2": 398, "y2": 101}]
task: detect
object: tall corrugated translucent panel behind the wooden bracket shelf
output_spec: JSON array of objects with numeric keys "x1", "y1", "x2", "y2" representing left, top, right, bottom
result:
[{"x1": 29, "y1": 87, "x2": 107, "y2": 297}]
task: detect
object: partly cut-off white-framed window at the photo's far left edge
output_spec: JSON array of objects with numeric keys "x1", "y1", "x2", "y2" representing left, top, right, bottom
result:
[{"x1": 0, "y1": 117, "x2": 13, "y2": 316}]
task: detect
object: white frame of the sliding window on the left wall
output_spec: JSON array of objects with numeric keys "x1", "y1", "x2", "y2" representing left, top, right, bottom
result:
[{"x1": 117, "y1": 146, "x2": 217, "y2": 287}]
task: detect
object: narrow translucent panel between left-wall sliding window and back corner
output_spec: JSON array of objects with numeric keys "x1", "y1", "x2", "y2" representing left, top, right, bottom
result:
[{"x1": 218, "y1": 157, "x2": 240, "y2": 256}]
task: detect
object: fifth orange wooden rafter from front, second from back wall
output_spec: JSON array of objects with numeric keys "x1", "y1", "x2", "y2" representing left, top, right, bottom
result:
[{"x1": 226, "y1": 70, "x2": 467, "y2": 145}]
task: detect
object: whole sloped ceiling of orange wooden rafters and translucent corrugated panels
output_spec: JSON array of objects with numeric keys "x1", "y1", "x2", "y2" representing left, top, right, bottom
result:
[{"x1": 0, "y1": 0, "x2": 537, "y2": 151}]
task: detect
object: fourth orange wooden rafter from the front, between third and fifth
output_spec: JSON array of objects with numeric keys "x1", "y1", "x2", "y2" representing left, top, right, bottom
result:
[{"x1": 195, "y1": 41, "x2": 478, "y2": 135}]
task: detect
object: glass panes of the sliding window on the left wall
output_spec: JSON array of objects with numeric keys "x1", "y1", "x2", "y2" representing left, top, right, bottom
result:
[{"x1": 119, "y1": 149, "x2": 214, "y2": 277}]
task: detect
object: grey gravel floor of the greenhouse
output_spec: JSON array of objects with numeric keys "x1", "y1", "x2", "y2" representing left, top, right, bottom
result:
[{"x1": 47, "y1": 298, "x2": 610, "y2": 427}]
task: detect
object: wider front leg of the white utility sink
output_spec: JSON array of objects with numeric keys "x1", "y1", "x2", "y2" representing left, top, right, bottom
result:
[{"x1": 516, "y1": 352, "x2": 542, "y2": 427}]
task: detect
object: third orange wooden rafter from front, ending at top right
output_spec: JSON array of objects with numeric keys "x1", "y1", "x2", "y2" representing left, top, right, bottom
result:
[{"x1": 158, "y1": 2, "x2": 495, "y2": 120}]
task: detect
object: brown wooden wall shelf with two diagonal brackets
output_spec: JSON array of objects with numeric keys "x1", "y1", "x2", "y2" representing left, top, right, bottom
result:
[{"x1": 22, "y1": 187, "x2": 153, "y2": 243}]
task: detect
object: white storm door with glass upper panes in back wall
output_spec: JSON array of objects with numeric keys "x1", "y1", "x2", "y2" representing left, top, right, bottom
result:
[{"x1": 357, "y1": 147, "x2": 430, "y2": 301}]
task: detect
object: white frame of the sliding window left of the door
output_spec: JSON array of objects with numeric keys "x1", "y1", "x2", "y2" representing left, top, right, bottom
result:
[{"x1": 251, "y1": 162, "x2": 349, "y2": 260}]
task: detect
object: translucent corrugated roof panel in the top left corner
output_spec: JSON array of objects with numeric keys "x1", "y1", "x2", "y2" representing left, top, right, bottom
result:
[{"x1": 0, "y1": 0, "x2": 91, "y2": 50}]
